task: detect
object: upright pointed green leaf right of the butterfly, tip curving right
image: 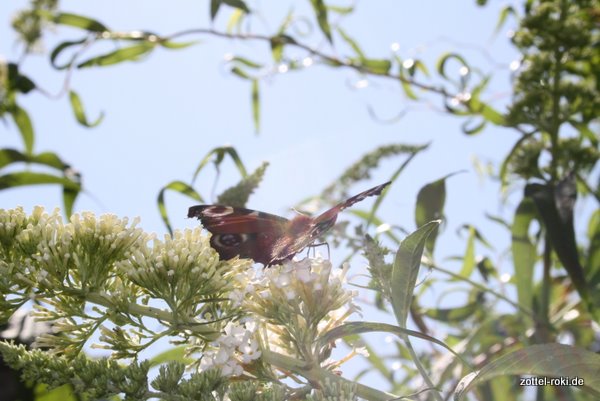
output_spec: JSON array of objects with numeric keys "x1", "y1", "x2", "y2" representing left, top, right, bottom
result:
[{"x1": 390, "y1": 220, "x2": 440, "y2": 328}]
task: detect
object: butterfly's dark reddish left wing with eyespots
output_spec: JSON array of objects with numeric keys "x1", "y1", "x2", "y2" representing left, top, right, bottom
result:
[{"x1": 188, "y1": 205, "x2": 289, "y2": 266}]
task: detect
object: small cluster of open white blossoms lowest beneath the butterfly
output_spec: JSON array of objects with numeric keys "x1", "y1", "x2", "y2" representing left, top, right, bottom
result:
[{"x1": 200, "y1": 319, "x2": 261, "y2": 376}]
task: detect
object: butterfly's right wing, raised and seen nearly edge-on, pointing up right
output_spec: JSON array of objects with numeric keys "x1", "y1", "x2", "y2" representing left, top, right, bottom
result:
[{"x1": 273, "y1": 181, "x2": 391, "y2": 263}]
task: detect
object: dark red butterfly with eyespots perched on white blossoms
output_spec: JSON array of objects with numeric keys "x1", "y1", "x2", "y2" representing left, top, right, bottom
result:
[{"x1": 188, "y1": 181, "x2": 391, "y2": 267}]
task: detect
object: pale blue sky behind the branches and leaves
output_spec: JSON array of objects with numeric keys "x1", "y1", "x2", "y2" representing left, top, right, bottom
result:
[{"x1": 0, "y1": 0, "x2": 528, "y2": 388}]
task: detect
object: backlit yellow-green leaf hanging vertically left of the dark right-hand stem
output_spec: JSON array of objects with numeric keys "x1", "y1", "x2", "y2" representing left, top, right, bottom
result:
[{"x1": 511, "y1": 198, "x2": 537, "y2": 308}]
